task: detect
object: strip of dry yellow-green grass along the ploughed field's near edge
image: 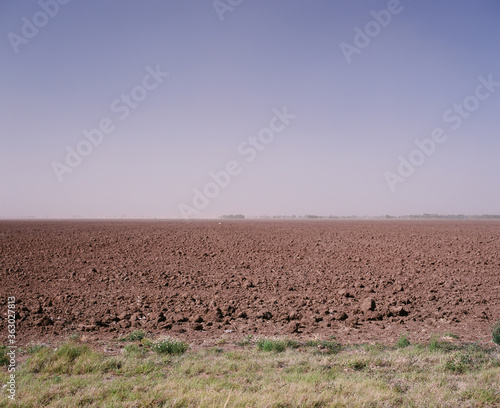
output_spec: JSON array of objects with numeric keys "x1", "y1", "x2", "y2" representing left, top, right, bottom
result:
[{"x1": 0, "y1": 338, "x2": 500, "y2": 408}]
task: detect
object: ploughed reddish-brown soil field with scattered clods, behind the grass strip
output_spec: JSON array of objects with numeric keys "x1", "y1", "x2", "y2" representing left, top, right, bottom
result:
[{"x1": 0, "y1": 221, "x2": 500, "y2": 344}]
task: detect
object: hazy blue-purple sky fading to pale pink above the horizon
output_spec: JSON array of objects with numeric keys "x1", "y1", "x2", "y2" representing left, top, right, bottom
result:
[{"x1": 0, "y1": 0, "x2": 500, "y2": 218}]
